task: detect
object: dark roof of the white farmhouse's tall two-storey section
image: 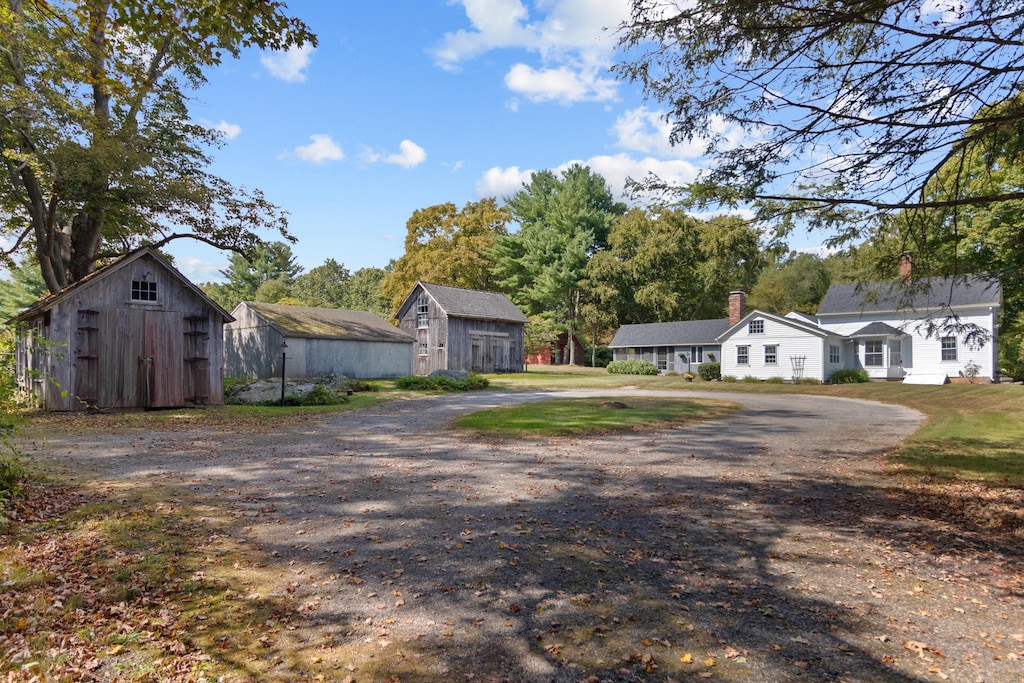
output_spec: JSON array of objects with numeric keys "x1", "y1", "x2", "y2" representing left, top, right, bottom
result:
[{"x1": 818, "y1": 275, "x2": 1002, "y2": 315}]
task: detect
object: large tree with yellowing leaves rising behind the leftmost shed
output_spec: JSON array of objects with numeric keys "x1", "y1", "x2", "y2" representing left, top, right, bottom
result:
[{"x1": 0, "y1": 0, "x2": 315, "y2": 291}]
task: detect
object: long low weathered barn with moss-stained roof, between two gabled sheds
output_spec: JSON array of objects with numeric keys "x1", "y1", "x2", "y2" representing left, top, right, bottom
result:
[{"x1": 224, "y1": 301, "x2": 415, "y2": 379}]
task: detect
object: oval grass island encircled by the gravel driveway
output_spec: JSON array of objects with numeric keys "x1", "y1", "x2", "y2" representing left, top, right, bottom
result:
[{"x1": 454, "y1": 398, "x2": 737, "y2": 436}]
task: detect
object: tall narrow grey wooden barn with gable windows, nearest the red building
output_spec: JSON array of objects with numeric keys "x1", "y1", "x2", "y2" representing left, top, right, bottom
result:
[{"x1": 395, "y1": 282, "x2": 527, "y2": 375}]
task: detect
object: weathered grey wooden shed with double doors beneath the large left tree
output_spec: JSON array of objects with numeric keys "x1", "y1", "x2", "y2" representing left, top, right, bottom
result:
[{"x1": 7, "y1": 247, "x2": 231, "y2": 411}]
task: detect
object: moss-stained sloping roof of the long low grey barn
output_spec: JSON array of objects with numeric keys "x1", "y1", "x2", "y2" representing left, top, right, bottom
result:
[{"x1": 234, "y1": 301, "x2": 414, "y2": 343}]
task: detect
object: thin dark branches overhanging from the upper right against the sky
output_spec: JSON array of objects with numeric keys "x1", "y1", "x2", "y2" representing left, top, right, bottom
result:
[{"x1": 616, "y1": 0, "x2": 1024, "y2": 240}]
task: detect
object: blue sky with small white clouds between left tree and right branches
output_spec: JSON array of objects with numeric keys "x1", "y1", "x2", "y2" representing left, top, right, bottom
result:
[{"x1": 170, "y1": 0, "x2": 807, "y2": 283}]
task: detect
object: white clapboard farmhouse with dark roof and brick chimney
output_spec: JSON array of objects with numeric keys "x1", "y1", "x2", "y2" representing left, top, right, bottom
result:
[{"x1": 717, "y1": 275, "x2": 1002, "y2": 382}]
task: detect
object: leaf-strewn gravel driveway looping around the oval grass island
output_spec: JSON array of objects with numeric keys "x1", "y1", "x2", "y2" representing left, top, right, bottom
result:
[{"x1": 18, "y1": 389, "x2": 1024, "y2": 681}]
